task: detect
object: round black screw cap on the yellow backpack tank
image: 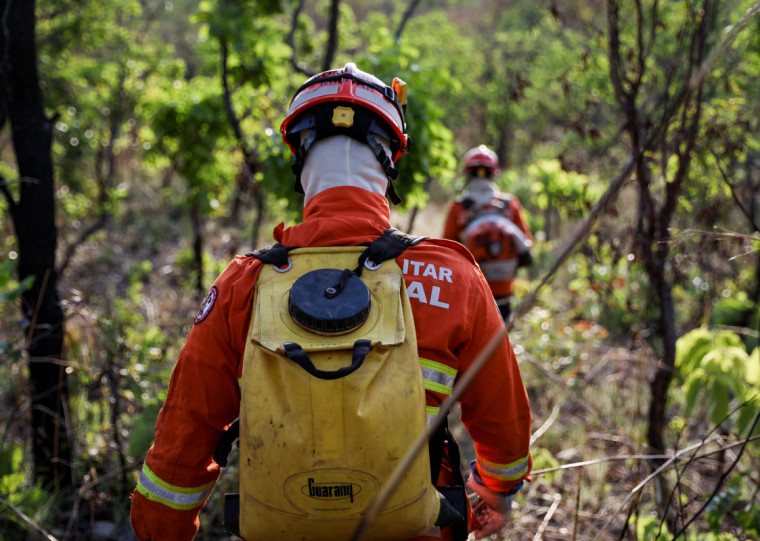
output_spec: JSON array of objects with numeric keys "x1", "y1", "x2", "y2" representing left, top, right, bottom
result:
[{"x1": 288, "y1": 269, "x2": 371, "y2": 335}]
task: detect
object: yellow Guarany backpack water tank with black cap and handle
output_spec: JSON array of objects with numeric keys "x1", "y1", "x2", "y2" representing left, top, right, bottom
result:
[{"x1": 215, "y1": 229, "x2": 466, "y2": 541}]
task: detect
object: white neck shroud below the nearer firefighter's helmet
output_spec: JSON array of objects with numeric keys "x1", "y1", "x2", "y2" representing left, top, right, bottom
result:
[{"x1": 301, "y1": 134, "x2": 391, "y2": 206}]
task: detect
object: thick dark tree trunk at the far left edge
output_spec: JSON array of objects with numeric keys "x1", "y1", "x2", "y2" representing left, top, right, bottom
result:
[{"x1": 0, "y1": 0, "x2": 74, "y2": 491}]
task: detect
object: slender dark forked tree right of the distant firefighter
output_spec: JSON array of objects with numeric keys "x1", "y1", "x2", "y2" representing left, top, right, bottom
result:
[{"x1": 607, "y1": 0, "x2": 717, "y2": 494}]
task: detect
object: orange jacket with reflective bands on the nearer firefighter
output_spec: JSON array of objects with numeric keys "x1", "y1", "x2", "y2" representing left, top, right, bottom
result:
[{"x1": 131, "y1": 187, "x2": 532, "y2": 541}]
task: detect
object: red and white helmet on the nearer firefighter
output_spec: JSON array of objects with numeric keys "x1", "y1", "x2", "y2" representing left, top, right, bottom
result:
[{"x1": 280, "y1": 63, "x2": 410, "y2": 203}]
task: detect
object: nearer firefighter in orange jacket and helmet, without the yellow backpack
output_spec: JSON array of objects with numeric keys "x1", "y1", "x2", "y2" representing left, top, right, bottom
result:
[{"x1": 131, "y1": 64, "x2": 532, "y2": 541}]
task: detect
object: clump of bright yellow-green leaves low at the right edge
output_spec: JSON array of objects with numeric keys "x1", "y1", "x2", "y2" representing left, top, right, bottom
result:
[{"x1": 675, "y1": 328, "x2": 760, "y2": 436}]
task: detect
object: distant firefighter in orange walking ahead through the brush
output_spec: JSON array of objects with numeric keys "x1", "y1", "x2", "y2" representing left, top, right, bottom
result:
[{"x1": 443, "y1": 145, "x2": 533, "y2": 321}]
